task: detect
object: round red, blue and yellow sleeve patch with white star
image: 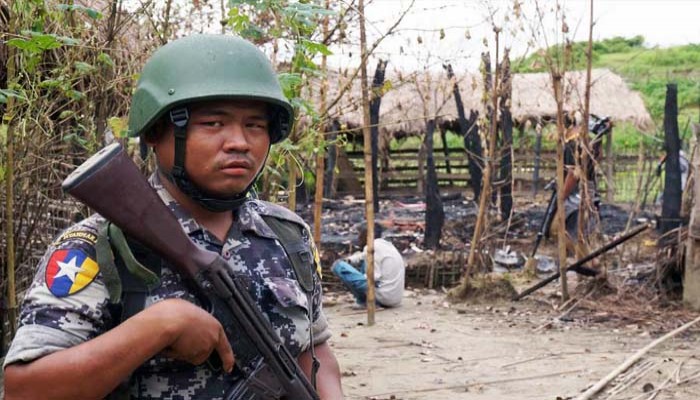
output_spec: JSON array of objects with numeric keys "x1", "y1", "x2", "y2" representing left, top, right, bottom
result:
[{"x1": 45, "y1": 249, "x2": 100, "y2": 297}]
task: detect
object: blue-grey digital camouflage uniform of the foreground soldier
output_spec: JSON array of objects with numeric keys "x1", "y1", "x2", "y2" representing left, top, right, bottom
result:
[{"x1": 5, "y1": 174, "x2": 330, "y2": 400}]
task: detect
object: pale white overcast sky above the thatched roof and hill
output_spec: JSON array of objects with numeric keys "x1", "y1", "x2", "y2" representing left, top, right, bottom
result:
[{"x1": 329, "y1": 0, "x2": 700, "y2": 71}]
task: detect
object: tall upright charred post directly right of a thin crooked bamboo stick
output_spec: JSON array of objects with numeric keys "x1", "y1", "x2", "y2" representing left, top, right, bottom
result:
[{"x1": 498, "y1": 50, "x2": 513, "y2": 221}]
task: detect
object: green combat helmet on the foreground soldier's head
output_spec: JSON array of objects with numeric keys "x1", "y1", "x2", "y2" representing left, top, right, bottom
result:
[{"x1": 129, "y1": 35, "x2": 294, "y2": 143}]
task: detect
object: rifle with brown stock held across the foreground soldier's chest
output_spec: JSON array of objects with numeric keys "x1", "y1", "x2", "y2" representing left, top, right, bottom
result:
[{"x1": 62, "y1": 143, "x2": 319, "y2": 400}]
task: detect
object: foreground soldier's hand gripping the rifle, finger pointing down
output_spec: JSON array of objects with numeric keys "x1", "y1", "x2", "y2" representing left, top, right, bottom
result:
[{"x1": 146, "y1": 299, "x2": 234, "y2": 372}]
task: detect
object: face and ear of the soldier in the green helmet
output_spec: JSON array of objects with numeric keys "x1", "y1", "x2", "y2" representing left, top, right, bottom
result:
[{"x1": 151, "y1": 100, "x2": 270, "y2": 197}]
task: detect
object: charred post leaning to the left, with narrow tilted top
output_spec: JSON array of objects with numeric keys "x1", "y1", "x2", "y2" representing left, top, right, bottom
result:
[{"x1": 444, "y1": 64, "x2": 483, "y2": 202}]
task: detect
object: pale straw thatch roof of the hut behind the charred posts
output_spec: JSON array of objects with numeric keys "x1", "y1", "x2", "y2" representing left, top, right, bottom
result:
[{"x1": 322, "y1": 69, "x2": 653, "y2": 133}]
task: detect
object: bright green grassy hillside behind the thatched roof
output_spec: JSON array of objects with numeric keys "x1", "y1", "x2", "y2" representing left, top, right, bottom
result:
[{"x1": 513, "y1": 36, "x2": 700, "y2": 148}]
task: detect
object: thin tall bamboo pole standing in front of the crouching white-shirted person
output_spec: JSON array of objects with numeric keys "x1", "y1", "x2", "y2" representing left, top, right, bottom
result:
[{"x1": 357, "y1": 0, "x2": 376, "y2": 326}]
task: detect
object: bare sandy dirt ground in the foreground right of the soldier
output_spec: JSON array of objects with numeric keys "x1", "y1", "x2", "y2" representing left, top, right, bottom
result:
[{"x1": 326, "y1": 292, "x2": 700, "y2": 400}]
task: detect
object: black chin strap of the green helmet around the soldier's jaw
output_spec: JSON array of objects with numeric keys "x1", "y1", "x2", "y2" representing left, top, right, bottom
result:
[{"x1": 163, "y1": 107, "x2": 262, "y2": 212}]
